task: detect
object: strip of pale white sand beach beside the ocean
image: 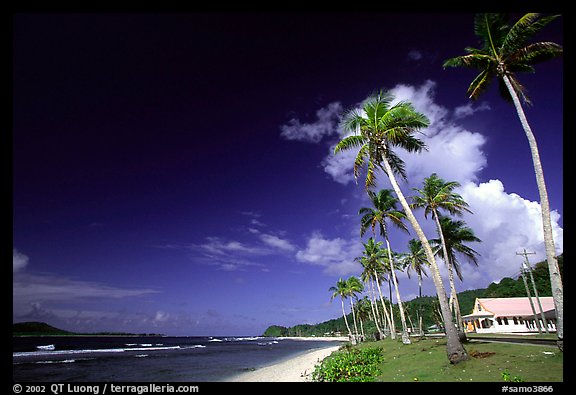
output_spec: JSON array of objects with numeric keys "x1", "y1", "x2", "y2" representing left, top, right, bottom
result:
[{"x1": 228, "y1": 346, "x2": 340, "y2": 382}]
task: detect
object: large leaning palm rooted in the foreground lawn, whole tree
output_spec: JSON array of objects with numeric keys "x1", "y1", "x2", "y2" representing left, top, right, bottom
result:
[{"x1": 334, "y1": 91, "x2": 469, "y2": 364}]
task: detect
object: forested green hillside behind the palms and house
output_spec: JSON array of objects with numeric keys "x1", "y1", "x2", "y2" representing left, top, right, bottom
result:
[{"x1": 264, "y1": 255, "x2": 564, "y2": 337}]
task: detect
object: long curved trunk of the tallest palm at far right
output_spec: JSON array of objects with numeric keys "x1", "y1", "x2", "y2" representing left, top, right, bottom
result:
[{"x1": 502, "y1": 74, "x2": 564, "y2": 351}]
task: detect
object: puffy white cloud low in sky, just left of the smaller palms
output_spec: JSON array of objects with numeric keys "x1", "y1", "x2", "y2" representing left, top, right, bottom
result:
[{"x1": 296, "y1": 232, "x2": 362, "y2": 276}]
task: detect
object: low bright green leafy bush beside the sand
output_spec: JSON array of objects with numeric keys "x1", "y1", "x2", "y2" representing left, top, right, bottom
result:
[{"x1": 312, "y1": 348, "x2": 384, "y2": 382}]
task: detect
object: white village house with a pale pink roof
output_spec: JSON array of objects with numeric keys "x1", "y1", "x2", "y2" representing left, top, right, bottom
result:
[{"x1": 462, "y1": 296, "x2": 556, "y2": 333}]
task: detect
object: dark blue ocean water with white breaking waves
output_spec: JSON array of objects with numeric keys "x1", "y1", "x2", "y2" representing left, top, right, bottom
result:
[{"x1": 12, "y1": 336, "x2": 338, "y2": 382}]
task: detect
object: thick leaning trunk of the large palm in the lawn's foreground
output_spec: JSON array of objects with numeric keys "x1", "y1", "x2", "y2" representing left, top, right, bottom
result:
[{"x1": 382, "y1": 151, "x2": 469, "y2": 364}]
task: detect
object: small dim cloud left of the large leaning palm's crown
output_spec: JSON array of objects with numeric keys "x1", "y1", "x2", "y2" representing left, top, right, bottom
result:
[{"x1": 280, "y1": 102, "x2": 342, "y2": 143}]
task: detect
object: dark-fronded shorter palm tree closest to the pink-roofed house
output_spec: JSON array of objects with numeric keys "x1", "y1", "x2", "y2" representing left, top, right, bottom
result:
[{"x1": 430, "y1": 216, "x2": 482, "y2": 331}]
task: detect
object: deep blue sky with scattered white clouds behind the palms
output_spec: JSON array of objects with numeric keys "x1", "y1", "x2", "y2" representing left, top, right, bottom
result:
[{"x1": 12, "y1": 12, "x2": 563, "y2": 335}]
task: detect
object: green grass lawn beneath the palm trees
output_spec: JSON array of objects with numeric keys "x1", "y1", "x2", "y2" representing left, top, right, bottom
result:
[{"x1": 343, "y1": 339, "x2": 563, "y2": 382}]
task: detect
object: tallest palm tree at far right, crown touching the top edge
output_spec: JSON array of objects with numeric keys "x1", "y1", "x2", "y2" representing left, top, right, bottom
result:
[{"x1": 444, "y1": 13, "x2": 564, "y2": 350}]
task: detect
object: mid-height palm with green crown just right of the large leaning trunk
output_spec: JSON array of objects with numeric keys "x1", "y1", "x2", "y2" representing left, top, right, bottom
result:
[{"x1": 411, "y1": 173, "x2": 471, "y2": 336}]
